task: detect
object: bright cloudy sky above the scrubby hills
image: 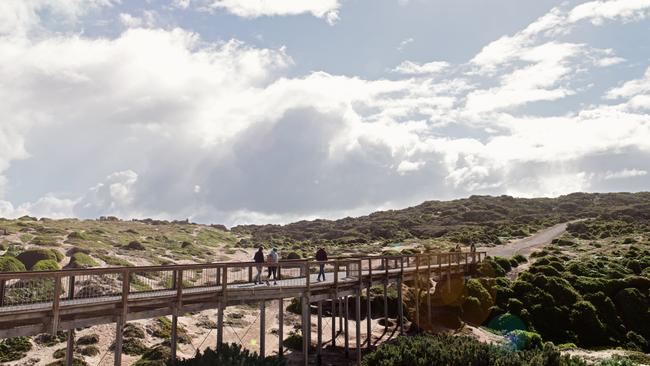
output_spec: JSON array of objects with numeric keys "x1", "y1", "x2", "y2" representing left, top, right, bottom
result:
[{"x1": 0, "y1": 0, "x2": 650, "y2": 226}]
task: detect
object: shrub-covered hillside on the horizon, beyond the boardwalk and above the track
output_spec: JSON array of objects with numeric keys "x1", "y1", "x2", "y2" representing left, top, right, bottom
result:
[{"x1": 232, "y1": 193, "x2": 650, "y2": 246}]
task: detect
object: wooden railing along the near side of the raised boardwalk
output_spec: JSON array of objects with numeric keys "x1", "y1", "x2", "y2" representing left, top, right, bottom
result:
[{"x1": 0, "y1": 252, "x2": 486, "y2": 313}]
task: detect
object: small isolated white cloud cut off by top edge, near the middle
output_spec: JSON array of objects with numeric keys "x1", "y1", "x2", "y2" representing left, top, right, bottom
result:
[{"x1": 210, "y1": 0, "x2": 341, "y2": 24}]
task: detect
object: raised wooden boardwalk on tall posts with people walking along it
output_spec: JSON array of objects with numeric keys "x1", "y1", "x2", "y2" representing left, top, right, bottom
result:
[{"x1": 0, "y1": 252, "x2": 486, "y2": 365}]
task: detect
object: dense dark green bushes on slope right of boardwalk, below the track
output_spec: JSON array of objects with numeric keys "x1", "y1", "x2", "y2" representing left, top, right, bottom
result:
[{"x1": 463, "y1": 219, "x2": 650, "y2": 352}]
